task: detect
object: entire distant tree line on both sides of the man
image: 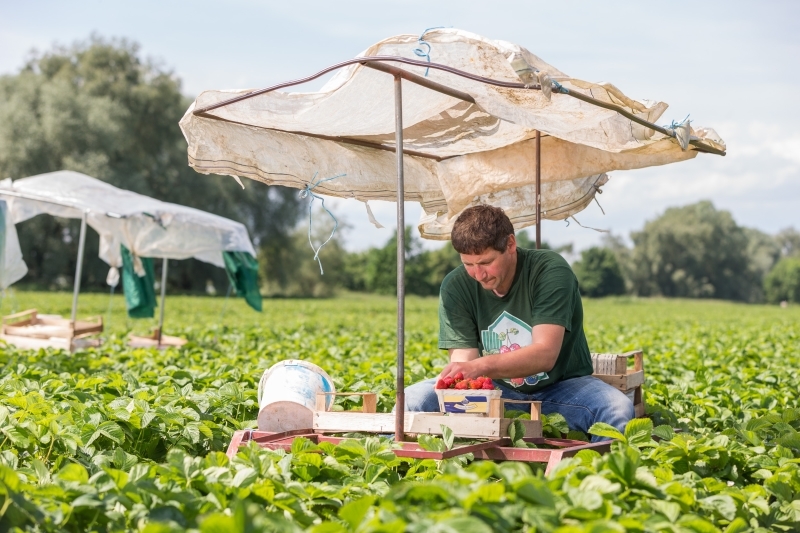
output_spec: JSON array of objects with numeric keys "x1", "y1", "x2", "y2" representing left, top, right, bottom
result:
[{"x1": 264, "y1": 201, "x2": 800, "y2": 303}]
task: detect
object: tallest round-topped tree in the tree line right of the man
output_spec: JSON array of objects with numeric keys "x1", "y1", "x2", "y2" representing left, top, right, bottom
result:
[{"x1": 631, "y1": 201, "x2": 760, "y2": 301}]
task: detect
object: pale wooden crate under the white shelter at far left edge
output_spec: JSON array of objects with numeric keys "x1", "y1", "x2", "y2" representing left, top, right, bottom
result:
[{"x1": 0, "y1": 309, "x2": 103, "y2": 351}]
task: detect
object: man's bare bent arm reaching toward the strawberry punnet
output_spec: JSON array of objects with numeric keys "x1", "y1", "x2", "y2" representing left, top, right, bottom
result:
[{"x1": 439, "y1": 324, "x2": 564, "y2": 379}]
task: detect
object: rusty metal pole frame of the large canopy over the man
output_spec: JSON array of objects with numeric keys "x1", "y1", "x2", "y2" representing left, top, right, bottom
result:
[{"x1": 193, "y1": 56, "x2": 725, "y2": 442}]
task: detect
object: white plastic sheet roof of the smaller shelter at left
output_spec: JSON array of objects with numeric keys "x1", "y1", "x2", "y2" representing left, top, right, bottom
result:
[{"x1": 0, "y1": 170, "x2": 260, "y2": 310}]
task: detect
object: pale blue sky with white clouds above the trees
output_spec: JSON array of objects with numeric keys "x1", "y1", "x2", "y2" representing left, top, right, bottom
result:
[{"x1": 0, "y1": 0, "x2": 800, "y2": 254}]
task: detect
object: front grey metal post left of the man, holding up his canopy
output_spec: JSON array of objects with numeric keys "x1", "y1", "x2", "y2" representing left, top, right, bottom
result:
[{"x1": 394, "y1": 74, "x2": 406, "y2": 442}]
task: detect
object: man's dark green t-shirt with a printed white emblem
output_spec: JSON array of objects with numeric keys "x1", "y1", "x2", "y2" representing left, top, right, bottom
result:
[{"x1": 439, "y1": 248, "x2": 592, "y2": 393}]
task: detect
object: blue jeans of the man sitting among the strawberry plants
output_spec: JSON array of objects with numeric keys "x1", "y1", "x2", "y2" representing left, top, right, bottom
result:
[{"x1": 405, "y1": 376, "x2": 634, "y2": 442}]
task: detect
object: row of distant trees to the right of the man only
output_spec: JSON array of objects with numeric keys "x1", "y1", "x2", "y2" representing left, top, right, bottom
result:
[{"x1": 573, "y1": 201, "x2": 800, "y2": 303}]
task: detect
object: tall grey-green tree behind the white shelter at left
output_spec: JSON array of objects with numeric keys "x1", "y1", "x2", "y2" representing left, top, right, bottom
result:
[{"x1": 0, "y1": 38, "x2": 299, "y2": 290}]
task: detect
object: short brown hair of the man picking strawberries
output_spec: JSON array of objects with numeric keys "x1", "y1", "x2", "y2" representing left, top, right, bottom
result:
[{"x1": 450, "y1": 205, "x2": 514, "y2": 254}]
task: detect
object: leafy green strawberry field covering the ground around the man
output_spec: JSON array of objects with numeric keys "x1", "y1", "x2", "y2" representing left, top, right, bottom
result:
[{"x1": 0, "y1": 293, "x2": 800, "y2": 533}]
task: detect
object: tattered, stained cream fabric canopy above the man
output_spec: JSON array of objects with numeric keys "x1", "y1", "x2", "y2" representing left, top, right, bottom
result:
[{"x1": 181, "y1": 28, "x2": 725, "y2": 239}]
